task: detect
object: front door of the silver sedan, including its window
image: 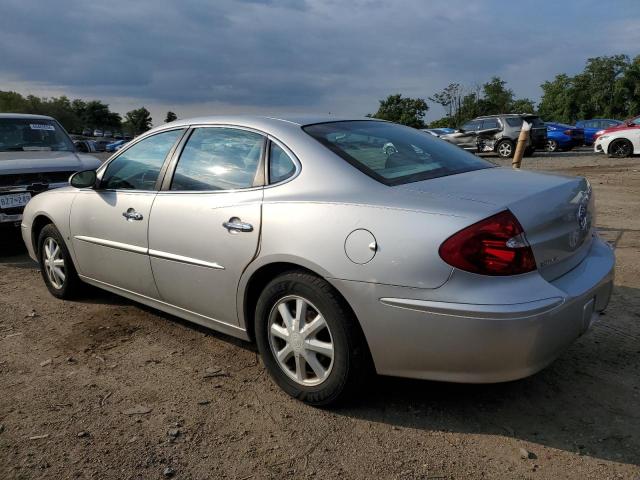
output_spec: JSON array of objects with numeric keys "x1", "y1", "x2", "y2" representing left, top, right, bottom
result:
[{"x1": 70, "y1": 129, "x2": 184, "y2": 298}]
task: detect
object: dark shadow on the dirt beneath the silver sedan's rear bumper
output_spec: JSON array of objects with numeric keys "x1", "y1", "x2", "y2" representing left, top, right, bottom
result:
[{"x1": 336, "y1": 287, "x2": 640, "y2": 465}]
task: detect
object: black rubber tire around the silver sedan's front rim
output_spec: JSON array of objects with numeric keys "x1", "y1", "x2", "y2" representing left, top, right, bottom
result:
[{"x1": 38, "y1": 223, "x2": 83, "y2": 299}]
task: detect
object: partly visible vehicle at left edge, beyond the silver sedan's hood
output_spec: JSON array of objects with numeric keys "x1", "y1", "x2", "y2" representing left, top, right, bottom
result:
[{"x1": 0, "y1": 113, "x2": 100, "y2": 229}]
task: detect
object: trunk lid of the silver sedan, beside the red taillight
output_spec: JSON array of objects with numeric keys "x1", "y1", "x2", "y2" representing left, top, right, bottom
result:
[{"x1": 398, "y1": 168, "x2": 595, "y2": 280}]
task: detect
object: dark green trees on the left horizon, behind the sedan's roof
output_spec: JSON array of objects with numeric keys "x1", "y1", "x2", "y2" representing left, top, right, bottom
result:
[{"x1": 0, "y1": 91, "x2": 178, "y2": 136}]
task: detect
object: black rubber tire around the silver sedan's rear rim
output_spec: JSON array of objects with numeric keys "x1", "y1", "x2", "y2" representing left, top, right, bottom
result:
[{"x1": 255, "y1": 271, "x2": 372, "y2": 406}]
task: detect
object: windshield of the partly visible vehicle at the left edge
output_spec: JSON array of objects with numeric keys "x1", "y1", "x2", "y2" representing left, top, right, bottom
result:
[{"x1": 0, "y1": 118, "x2": 75, "y2": 152}]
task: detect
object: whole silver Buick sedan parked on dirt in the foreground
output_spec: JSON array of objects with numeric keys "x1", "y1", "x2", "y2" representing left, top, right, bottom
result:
[{"x1": 22, "y1": 116, "x2": 614, "y2": 405}]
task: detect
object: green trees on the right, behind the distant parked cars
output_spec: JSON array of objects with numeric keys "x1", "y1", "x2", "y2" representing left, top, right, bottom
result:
[{"x1": 369, "y1": 55, "x2": 640, "y2": 128}]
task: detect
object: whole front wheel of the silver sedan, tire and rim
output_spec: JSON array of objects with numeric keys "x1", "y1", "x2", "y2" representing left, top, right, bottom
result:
[{"x1": 38, "y1": 224, "x2": 82, "y2": 299}]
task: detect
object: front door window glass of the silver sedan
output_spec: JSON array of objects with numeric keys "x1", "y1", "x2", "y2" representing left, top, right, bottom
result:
[{"x1": 100, "y1": 129, "x2": 184, "y2": 190}]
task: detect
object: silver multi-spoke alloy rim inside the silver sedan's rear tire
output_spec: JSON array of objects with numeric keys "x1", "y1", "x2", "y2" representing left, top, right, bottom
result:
[{"x1": 268, "y1": 295, "x2": 334, "y2": 386}]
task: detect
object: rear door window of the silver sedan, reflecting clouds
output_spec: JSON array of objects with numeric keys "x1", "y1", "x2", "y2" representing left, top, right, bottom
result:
[{"x1": 171, "y1": 127, "x2": 266, "y2": 191}]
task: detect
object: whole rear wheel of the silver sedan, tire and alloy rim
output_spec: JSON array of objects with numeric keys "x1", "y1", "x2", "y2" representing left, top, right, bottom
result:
[{"x1": 255, "y1": 272, "x2": 368, "y2": 406}]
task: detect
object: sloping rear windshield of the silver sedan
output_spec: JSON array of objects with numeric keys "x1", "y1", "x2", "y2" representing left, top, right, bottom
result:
[{"x1": 303, "y1": 120, "x2": 495, "y2": 185}]
